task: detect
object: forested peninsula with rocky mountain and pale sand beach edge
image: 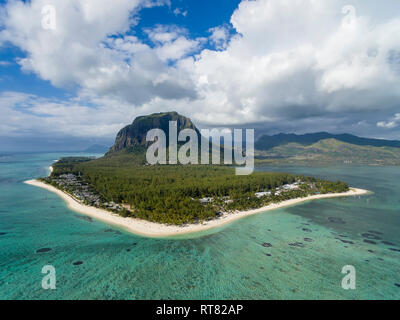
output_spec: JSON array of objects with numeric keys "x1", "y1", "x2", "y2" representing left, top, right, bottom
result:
[{"x1": 26, "y1": 113, "x2": 368, "y2": 237}]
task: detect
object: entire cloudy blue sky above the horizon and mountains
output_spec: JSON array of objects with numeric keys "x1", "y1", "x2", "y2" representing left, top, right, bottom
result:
[{"x1": 0, "y1": 0, "x2": 400, "y2": 152}]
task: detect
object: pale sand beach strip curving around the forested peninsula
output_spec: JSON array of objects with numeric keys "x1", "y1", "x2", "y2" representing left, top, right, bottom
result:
[{"x1": 24, "y1": 180, "x2": 371, "y2": 238}]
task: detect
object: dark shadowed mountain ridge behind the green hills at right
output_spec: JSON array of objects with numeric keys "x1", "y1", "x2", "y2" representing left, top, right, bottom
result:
[{"x1": 255, "y1": 132, "x2": 400, "y2": 150}]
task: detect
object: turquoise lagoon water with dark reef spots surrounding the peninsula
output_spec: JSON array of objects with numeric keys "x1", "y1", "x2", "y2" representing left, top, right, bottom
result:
[{"x1": 0, "y1": 154, "x2": 400, "y2": 299}]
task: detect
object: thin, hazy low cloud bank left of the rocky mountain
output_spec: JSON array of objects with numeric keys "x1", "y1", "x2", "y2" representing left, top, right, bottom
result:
[{"x1": 0, "y1": 91, "x2": 127, "y2": 137}]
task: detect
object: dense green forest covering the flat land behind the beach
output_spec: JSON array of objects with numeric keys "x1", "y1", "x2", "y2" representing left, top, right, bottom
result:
[{"x1": 45, "y1": 153, "x2": 348, "y2": 225}]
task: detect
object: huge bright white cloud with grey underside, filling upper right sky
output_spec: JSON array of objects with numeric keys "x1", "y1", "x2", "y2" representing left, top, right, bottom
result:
[{"x1": 180, "y1": 0, "x2": 400, "y2": 129}]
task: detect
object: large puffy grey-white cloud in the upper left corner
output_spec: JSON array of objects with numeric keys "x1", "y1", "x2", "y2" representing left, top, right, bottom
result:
[{"x1": 0, "y1": 0, "x2": 195, "y2": 105}]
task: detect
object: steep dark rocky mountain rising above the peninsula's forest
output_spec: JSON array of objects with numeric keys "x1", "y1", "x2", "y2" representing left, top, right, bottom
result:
[{"x1": 107, "y1": 112, "x2": 200, "y2": 155}]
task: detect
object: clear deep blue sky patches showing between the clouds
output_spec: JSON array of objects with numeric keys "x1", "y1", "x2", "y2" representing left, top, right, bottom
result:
[{"x1": 0, "y1": 0, "x2": 240, "y2": 99}]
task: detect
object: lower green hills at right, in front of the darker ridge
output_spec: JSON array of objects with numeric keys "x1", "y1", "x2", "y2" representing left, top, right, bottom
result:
[{"x1": 256, "y1": 139, "x2": 400, "y2": 165}]
